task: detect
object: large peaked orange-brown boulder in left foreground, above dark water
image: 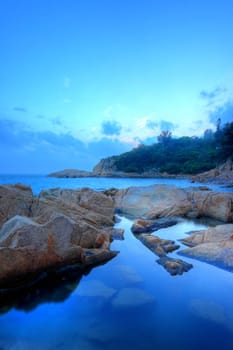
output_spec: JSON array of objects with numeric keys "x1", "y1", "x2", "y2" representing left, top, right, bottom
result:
[{"x1": 0, "y1": 214, "x2": 116, "y2": 285}]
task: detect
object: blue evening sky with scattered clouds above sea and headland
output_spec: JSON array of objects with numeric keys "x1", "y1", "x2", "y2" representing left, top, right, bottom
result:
[{"x1": 0, "y1": 0, "x2": 233, "y2": 174}]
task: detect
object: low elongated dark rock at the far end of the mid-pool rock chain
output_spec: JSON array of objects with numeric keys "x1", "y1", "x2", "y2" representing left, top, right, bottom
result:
[{"x1": 131, "y1": 219, "x2": 178, "y2": 234}]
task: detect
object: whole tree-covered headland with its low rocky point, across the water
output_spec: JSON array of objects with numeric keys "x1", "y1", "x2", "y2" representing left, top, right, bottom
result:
[{"x1": 49, "y1": 122, "x2": 233, "y2": 183}]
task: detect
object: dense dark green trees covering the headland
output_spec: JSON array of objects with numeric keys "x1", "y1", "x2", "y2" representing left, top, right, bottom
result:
[{"x1": 115, "y1": 121, "x2": 233, "y2": 174}]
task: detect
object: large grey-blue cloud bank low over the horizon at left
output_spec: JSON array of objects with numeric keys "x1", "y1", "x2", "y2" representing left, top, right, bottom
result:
[{"x1": 0, "y1": 116, "x2": 131, "y2": 174}]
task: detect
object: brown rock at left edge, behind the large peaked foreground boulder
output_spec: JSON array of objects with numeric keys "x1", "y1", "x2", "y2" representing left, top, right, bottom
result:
[{"x1": 0, "y1": 183, "x2": 33, "y2": 227}]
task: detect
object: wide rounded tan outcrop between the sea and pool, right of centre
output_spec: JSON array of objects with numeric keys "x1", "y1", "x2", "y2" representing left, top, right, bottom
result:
[{"x1": 112, "y1": 185, "x2": 233, "y2": 222}]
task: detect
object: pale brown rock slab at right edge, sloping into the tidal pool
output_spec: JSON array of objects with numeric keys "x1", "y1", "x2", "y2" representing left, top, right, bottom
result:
[{"x1": 179, "y1": 224, "x2": 233, "y2": 271}]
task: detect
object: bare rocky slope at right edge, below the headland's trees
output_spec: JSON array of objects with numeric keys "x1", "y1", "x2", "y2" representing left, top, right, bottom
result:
[{"x1": 192, "y1": 160, "x2": 233, "y2": 186}]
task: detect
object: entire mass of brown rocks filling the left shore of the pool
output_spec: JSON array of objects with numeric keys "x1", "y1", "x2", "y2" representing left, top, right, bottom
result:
[{"x1": 0, "y1": 185, "x2": 117, "y2": 288}]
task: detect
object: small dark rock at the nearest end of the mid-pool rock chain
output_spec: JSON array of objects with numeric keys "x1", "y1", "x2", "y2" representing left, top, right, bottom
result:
[{"x1": 157, "y1": 256, "x2": 193, "y2": 276}]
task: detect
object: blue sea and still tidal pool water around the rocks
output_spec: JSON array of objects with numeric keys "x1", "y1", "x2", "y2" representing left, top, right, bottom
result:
[{"x1": 0, "y1": 175, "x2": 233, "y2": 350}]
